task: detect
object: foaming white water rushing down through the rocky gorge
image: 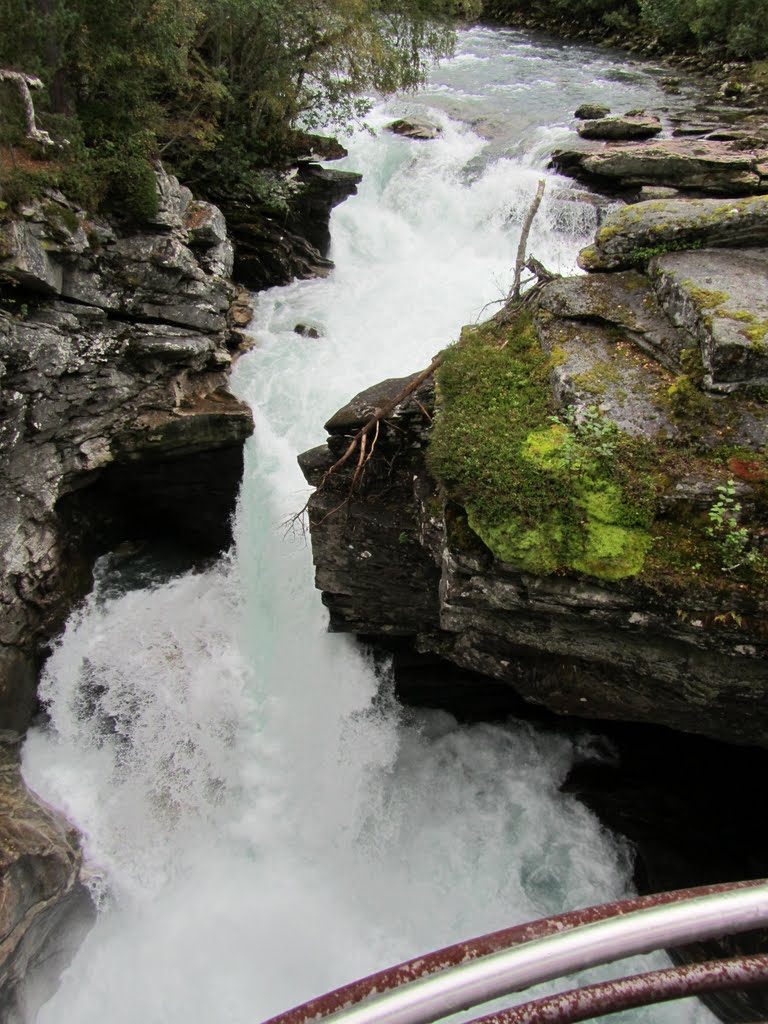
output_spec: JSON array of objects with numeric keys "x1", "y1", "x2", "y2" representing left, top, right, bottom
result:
[{"x1": 25, "y1": 24, "x2": 720, "y2": 1024}]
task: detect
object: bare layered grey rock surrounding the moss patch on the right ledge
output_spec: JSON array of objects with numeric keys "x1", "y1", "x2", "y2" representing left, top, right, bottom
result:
[{"x1": 300, "y1": 195, "x2": 768, "y2": 746}]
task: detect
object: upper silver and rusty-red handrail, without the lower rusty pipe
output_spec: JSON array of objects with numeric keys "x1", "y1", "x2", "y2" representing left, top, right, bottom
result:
[{"x1": 268, "y1": 880, "x2": 768, "y2": 1024}]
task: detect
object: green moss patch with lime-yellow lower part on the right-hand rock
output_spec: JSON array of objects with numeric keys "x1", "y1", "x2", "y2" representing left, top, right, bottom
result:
[{"x1": 428, "y1": 313, "x2": 655, "y2": 580}]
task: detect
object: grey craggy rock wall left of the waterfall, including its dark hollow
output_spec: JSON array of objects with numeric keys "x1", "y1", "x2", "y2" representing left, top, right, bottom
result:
[{"x1": 0, "y1": 171, "x2": 253, "y2": 1007}]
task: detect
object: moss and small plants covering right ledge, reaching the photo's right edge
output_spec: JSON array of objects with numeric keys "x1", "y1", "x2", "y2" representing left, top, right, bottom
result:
[{"x1": 427, "y1": 310, "x2": 768, "y2": 598}]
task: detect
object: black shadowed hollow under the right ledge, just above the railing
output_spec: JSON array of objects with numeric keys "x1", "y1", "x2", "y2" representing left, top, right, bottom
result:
[{"x1": 564, "y1": 723, "x2": 768, "y2": 1024}]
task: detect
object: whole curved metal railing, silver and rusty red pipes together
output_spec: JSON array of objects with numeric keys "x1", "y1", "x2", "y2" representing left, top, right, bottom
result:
[{"x1": 266, "y1": 879, "x2": 768, "y2": 1024}]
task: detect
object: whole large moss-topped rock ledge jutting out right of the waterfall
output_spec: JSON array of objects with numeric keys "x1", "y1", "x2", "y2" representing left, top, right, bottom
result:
[{"x1": 300, "y1": 198, "x2": 768, "y2": 746}]
